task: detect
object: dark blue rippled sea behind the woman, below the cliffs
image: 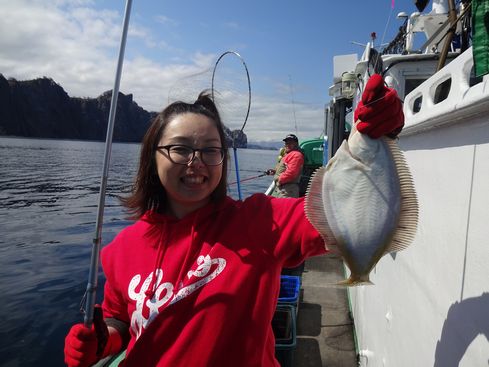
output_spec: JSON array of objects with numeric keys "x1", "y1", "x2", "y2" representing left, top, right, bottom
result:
[{"x1": 0, "y1": 137, "x2": 277, "y2": 367}]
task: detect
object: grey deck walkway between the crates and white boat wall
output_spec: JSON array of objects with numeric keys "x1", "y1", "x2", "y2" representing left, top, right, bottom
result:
[{"x1": 294, "y1": 256, "x2": 358, "y2": 367}]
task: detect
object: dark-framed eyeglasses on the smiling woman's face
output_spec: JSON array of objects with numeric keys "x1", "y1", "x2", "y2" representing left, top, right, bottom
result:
[{"x1": 156, "y1": 144, "x2": 224, "y2": 166}]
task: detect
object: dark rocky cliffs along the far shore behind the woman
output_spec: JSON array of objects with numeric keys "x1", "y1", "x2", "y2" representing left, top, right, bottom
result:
[{"x1": 0, "y1": 74, "x2": 247, "y2": 148}]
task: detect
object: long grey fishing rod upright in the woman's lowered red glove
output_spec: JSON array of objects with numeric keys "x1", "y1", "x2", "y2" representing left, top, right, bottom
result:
[{"x1": 82, "y1": 0, "x2": 132, "y2": 328}]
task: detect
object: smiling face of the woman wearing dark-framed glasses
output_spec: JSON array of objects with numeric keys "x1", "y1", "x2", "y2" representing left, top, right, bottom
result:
[{"x1": 155, "y1": 113, "x2": 222, "y2": 218}]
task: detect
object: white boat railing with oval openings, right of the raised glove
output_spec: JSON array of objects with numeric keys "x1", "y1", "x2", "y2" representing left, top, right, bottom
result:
[{"x1": 402, "y1": 47, "x2": 489, "y2": 135}]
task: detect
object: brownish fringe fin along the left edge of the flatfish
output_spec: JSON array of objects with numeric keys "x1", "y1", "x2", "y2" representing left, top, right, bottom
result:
[{"x1": 304, "y1": 167, "x2": 339, "y2": 253}]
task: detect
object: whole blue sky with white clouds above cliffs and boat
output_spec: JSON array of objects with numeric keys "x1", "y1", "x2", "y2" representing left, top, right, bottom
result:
[{"x1": 0, "y1": 0, "x2": 430, "y2": 142}]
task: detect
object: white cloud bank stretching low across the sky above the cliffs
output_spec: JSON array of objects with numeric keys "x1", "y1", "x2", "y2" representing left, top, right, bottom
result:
[{"x1": 0, "y1": 0, "x2": 324, "y2": 141}]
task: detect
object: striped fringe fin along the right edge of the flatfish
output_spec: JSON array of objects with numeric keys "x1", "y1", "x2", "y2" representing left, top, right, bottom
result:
[{"x1": 382, "y1": 138, "x2": 419, "y2": 253}]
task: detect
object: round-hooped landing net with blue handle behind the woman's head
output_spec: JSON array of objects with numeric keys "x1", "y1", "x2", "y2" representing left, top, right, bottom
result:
[{"x1": 211, "y1": 51, "x2": 251, "y2": 200}]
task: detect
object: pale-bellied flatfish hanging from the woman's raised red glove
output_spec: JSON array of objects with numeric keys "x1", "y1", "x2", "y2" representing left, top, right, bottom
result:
[{"x1": 305, "y1": 125, "x2": 418, "y2": 285}]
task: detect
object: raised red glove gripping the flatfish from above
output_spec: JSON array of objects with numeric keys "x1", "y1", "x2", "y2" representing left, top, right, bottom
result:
[{"x1": 354, "y1": 74, "x2": 404, "y2": 139}]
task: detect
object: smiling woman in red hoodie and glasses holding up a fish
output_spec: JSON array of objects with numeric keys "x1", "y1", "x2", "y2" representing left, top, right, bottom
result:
[{"x1": 65, "y1": 75, "x2": 402, "y2": 366}]
